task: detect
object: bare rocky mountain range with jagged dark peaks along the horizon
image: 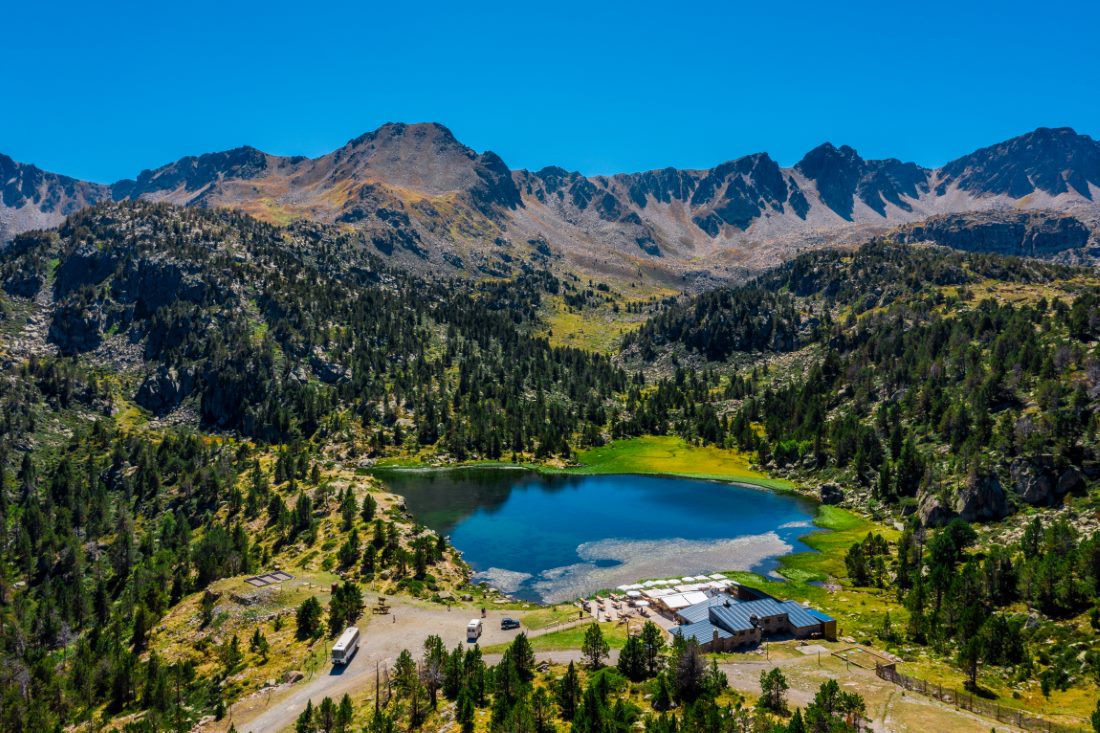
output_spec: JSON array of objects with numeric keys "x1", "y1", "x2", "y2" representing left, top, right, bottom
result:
[{"x1": 0, "y1": 123, "x2": 1100, "y2": 287}]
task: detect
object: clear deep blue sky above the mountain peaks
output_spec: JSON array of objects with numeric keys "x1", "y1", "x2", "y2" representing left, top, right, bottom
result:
[{"x1": 8, "y1": 0, "x2": 1100, "y2": 182}]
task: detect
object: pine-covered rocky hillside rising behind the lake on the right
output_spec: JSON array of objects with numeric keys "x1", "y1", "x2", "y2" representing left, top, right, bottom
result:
[{"x1": 626, "y1": 242, "x2": 1100, "y2": 525}]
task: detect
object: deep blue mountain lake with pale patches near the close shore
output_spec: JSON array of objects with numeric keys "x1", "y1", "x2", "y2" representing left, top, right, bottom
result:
[{"x1": 377, "y1": 468, "x2": 814, "y2": 601}]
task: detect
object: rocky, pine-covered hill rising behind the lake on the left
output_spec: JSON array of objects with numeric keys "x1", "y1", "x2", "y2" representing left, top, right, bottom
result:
[{"x1": 2, "y1": 198, "x2": 626, "y2": 458}]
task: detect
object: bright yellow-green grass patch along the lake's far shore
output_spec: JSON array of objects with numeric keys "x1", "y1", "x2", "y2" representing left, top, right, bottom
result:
[{"x1": 568, "y1": 436, "x2": 794, "y2": 491}]
